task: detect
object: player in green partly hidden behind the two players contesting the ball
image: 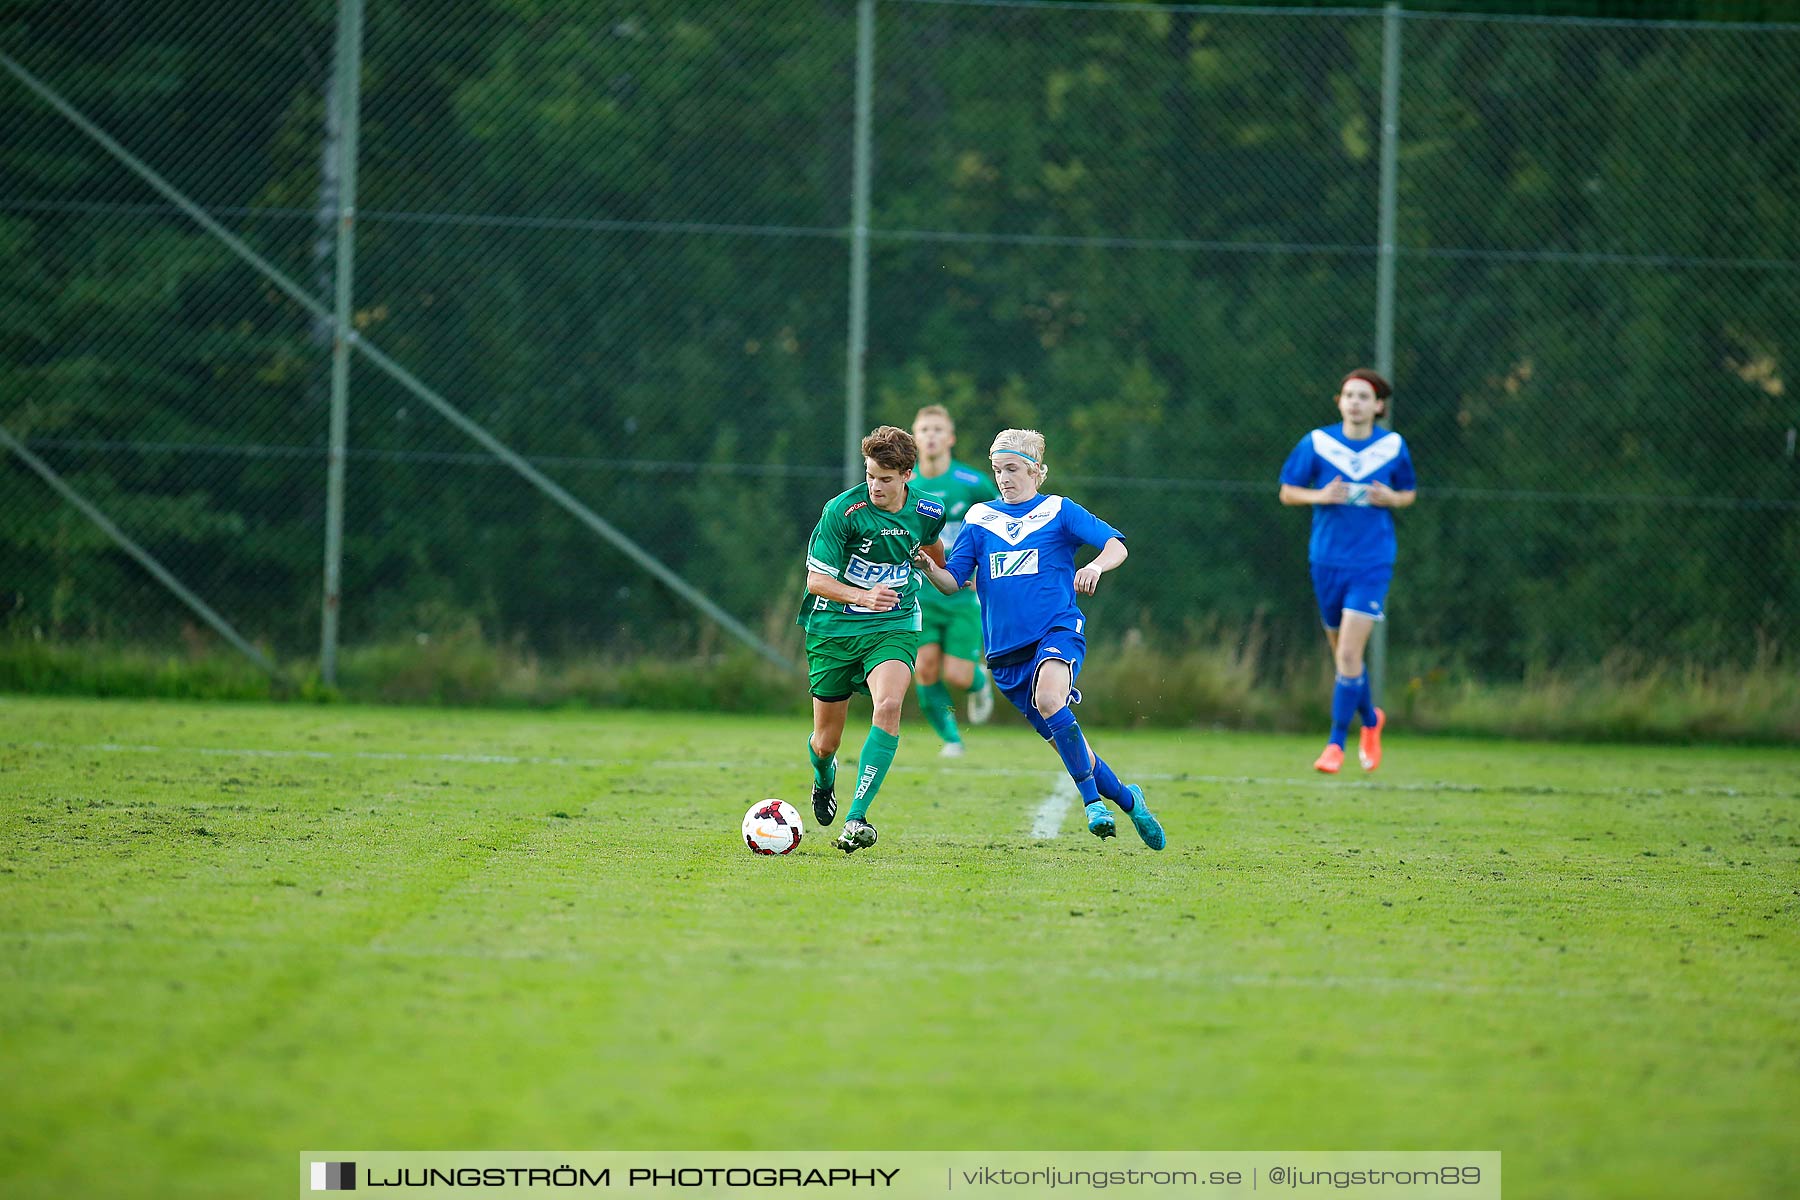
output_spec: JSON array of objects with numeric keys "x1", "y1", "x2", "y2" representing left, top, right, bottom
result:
[{"x1": 913, "y1": 405, "x2": 999, "y2": 757}]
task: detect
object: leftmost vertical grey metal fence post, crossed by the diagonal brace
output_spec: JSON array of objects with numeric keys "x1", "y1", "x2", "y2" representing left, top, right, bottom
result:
[{"x1": 319, "y1": 0, "x2": 362, "y2": 684}]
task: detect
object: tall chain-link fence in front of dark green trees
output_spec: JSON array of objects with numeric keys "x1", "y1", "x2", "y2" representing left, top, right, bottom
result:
[{"x1": 0, "y1": 0, "x2": 1800, "y2": 675}]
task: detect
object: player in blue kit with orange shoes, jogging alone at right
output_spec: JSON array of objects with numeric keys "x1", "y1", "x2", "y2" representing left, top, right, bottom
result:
[{"x1": 1282, "y1": 369, "x2": 1418, "y2": 775}]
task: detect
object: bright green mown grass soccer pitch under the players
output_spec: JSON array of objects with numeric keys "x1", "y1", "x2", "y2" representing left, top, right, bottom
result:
[{"x1": 0, "y1": 698, "x2": 1800, "y2": 1196}]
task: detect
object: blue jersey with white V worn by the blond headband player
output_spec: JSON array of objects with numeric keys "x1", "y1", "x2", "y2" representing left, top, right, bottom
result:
[{"x1": 943, "y1": 497, "x2": 1125, "y2": 658}]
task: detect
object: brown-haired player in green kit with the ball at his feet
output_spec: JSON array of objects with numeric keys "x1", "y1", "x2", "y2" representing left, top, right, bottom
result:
[{"x1": 799, "y1": 425, "x2": 943, "y2": 855}]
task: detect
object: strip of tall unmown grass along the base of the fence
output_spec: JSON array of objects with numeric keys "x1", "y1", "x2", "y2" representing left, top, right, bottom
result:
[{"x1": 0, "y1": 621, "x2": 1800, "y2": 743}]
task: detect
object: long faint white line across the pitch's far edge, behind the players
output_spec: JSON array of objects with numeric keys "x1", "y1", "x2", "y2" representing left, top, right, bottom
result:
[{"x1": 0, "y1": 741, "x2": 1800, "y2": 799}]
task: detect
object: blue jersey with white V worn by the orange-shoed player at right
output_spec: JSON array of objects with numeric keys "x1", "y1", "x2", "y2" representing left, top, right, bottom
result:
[{"x1": 1282, "y1": 421, "x2": 1418, "y2": 567}]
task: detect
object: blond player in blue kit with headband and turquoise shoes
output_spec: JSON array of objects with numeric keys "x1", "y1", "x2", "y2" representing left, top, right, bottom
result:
[{"x1": 913, "y1": 430, "x2": 1165, "y2": 849}]
